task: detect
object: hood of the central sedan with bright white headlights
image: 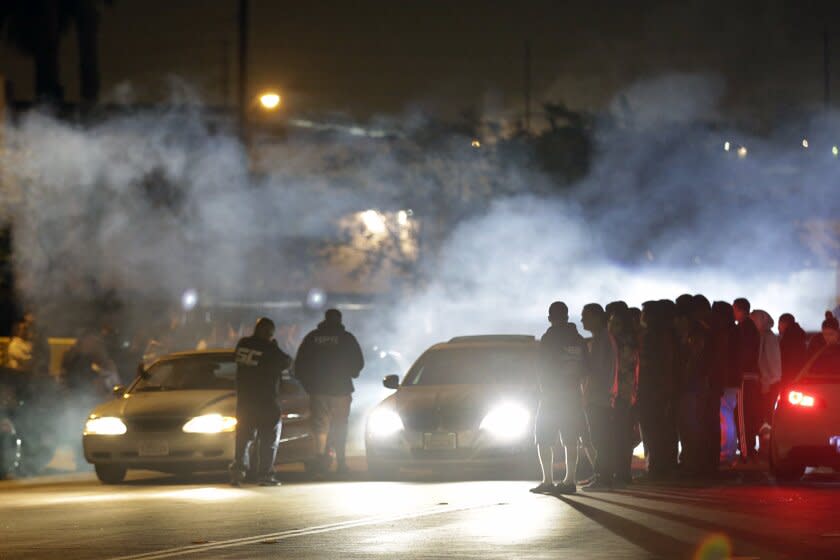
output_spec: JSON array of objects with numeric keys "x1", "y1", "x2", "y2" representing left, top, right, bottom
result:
[{"x1": 382, "y1": 385, "x2": 536, "y2": 430}]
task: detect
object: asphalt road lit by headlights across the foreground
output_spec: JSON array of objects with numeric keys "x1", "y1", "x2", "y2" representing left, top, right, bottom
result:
[{"x1": 0, "y1": 473, "x2": 840, "y2": 560}]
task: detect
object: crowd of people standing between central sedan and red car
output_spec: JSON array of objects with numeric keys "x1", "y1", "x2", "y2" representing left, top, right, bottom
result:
[{"x1": 532, "y1": 294, "x2": 840, "y2": 493}]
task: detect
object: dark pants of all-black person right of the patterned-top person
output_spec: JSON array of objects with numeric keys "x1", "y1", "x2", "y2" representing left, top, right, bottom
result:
[{"x1": 638, "y1": 397, "x2": 677, "y2": 477}]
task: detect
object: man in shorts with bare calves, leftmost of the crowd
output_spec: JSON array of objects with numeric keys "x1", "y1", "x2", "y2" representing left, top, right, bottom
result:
[{"x1": 531, "y1": 301, "x2": 584, "y2": 494}]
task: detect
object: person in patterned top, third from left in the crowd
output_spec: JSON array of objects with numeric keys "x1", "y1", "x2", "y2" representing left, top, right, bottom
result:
[{"x1": 608, "y1": 310, "x2": 639, "y2": 486}]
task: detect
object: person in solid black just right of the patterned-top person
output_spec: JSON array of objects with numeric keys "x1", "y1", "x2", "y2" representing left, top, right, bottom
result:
[{"x1": 637, "y1": 301, "x2": 677, "y2": 480}]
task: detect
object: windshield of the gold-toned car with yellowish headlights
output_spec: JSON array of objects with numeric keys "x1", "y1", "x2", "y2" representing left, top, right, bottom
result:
[{"x1": 132, "y1": 356, "x2": 236, "y2": 392}]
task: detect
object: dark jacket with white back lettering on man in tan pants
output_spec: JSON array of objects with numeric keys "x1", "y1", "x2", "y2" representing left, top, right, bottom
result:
[{"x1": 295, "y1": 322, "x2": 365, "y2": 396}]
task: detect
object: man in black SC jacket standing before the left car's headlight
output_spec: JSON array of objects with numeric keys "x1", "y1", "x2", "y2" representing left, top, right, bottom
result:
[{"x1": 230, "y1": 317, "x2": 291, "y2": 486}]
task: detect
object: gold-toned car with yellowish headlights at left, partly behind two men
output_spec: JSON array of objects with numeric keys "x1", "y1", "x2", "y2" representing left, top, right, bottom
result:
[{"x1": 82, "y1": 350, "x2": 314, "y2": 484}]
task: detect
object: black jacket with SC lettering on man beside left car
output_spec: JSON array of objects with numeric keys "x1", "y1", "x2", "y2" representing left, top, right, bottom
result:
[{"x1": 236, "y1": 336, "x2": 291, "y2": 414}]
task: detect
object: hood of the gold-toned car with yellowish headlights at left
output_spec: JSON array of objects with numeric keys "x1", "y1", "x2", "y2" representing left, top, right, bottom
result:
[{"x1": 92, "y1": 390, "x2": 236, "y2": 418}]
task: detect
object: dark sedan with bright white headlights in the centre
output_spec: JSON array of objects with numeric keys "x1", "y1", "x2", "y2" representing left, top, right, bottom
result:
[{"x1": 365, "y1": 335, "x2": 538, "y2": 477}]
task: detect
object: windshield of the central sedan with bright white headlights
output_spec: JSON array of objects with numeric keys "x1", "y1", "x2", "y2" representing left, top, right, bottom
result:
[{"x1": 403, "y1": 347, "x2": 537, "y2": 386}]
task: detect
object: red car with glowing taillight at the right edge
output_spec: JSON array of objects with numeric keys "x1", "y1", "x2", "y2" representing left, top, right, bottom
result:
[{"x1": 770, "y1": 345, "x2": 840, "y2": 482}]
